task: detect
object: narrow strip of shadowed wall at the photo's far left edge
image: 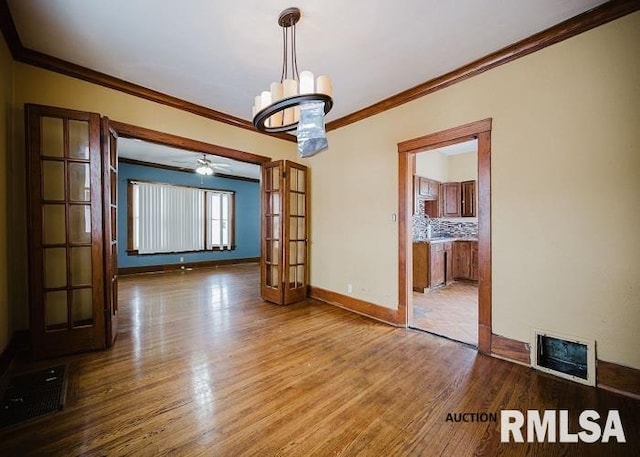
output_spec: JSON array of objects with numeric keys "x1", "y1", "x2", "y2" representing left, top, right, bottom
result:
[{"x1": 0, "y1": 34, "x2": 13, "y2": 354}]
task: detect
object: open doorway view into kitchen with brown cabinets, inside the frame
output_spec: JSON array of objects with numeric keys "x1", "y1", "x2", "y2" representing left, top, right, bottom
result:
[{"x1": 408, "y1": 139, "x2": 478, "y2": 347}]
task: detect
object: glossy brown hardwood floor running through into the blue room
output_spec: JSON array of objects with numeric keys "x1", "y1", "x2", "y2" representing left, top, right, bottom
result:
[{"x1": 0, "y1": 265, "x2": 640, "y2": 457}]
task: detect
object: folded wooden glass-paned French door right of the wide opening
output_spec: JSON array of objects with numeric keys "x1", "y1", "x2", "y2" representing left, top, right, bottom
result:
[{"x1": 260, "y1": 160, "x2": 309, "y2": 305}]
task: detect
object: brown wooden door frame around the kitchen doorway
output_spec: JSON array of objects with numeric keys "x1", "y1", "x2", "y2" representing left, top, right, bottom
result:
[{"x1": 396, "y1": 118, "x2": 491, "y2": 354}]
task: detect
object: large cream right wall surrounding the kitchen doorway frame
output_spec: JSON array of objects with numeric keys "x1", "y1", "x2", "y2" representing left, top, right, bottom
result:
[{"x1": 305, "y1": 12, "x2": 640, "y2": 368}]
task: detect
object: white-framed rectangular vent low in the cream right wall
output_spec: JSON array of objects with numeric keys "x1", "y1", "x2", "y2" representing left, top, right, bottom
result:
[{"x1": 531, "y1": 330, "x2": 596, "y2": 386}]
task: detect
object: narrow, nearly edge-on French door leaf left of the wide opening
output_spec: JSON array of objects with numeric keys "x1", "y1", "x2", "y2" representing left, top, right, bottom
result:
[{"x1": 101, "y1": 117, "x2": 118, "y2": 346}]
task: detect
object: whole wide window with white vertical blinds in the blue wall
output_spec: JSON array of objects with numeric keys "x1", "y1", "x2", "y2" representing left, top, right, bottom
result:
[{"x1": 128, "y1": 181, "x2": 234, "y2": 254}]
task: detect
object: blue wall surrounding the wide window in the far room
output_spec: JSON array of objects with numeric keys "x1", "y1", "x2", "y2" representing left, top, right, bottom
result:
[{"x1": 118, "y1": 162, "x2": 260, "y2": 268}]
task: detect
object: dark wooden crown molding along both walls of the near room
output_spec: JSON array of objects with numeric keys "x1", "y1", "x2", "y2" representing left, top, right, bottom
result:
[{"x1": 5, "y1": 0, "x2": 640, "y2": 135}]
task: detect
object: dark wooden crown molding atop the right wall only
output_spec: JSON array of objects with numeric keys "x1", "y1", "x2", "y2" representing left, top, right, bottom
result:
[{"x1": 326, "y1": 0, "x2": 640, "y2": 131}]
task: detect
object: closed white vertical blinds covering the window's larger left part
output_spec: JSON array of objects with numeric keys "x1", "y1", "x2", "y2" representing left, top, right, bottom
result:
[{"x1": 134, "y1": 182, "x2": 204, "y2": 254}]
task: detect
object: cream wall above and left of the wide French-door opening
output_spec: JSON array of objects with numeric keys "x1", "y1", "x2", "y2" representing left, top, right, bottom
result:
[{"x1": 8, "y1": 62, "x2": 296, "y2": 329}]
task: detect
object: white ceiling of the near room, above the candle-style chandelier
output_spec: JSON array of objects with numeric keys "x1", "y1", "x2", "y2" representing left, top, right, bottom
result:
[{"x1": 8, "y1": 0, "x2": 604, "y2": 121}]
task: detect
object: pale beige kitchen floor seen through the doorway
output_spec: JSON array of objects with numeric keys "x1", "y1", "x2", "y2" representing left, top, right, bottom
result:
[{"x1": 410, "y1": 282, "x2": 478, "y2": 346}]
